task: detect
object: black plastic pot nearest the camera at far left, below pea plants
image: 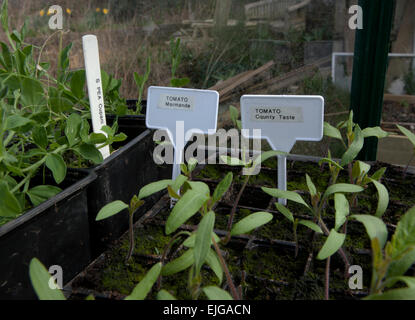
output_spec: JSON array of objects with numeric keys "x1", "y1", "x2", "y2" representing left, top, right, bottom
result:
[{"x1": 0, "y1": 169, "x2": 96, "y2": 300}]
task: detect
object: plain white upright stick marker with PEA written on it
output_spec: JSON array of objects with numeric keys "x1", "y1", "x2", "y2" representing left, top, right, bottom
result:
[{"x1": 82, "y1": 35, "x2": 110, "y2": 159}]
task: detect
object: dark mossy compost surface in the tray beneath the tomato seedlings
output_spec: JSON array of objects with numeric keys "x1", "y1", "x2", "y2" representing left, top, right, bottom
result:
[{"x1": 67, "y1": 161, "x2": 415, "y2": 300}]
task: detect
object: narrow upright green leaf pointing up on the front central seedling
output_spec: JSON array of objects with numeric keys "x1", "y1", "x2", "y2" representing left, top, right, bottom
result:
[{"x1": 193, "y1": 211, "x2": 215, "y2": 275}]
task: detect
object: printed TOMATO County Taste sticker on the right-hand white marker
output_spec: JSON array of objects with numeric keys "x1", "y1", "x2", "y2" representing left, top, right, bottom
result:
[{"x1": 251, "y1": 106, "x2": 304, "y2": 122}]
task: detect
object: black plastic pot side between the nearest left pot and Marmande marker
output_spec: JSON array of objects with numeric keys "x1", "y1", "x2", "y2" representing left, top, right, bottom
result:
[{"x1": 88, "y1": 125, "x2": 173, "y2": 257}]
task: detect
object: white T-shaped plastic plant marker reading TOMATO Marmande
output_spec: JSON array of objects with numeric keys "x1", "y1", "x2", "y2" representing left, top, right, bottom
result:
[{"x1": 146, "y1": 87, "x2": 219, "y2": 205}]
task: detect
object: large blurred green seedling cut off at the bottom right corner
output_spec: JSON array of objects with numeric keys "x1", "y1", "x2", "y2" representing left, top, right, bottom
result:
[{"x1": 350, "y1": 208, "x2": 415, "y2": 300}]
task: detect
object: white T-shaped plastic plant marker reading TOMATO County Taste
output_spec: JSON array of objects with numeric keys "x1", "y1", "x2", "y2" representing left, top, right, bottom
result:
[{"x1": 241, "y1": 95, "x2": 324, "y2": 205}]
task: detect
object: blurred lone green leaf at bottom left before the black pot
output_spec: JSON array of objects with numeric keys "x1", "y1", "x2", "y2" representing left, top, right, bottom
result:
[{"x1": 29, "y1": 258, "x2": 66, "y2": 300}]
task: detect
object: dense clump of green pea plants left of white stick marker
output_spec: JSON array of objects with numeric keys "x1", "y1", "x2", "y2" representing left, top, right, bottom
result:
[{"x1": 0, "y1": 0, "x2": 125, "y2": 225}]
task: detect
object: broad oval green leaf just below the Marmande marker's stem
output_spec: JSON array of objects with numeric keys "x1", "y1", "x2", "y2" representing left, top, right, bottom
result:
[{"x1": 166, "y1": 190, "x2": 209, "y2": 235}]
